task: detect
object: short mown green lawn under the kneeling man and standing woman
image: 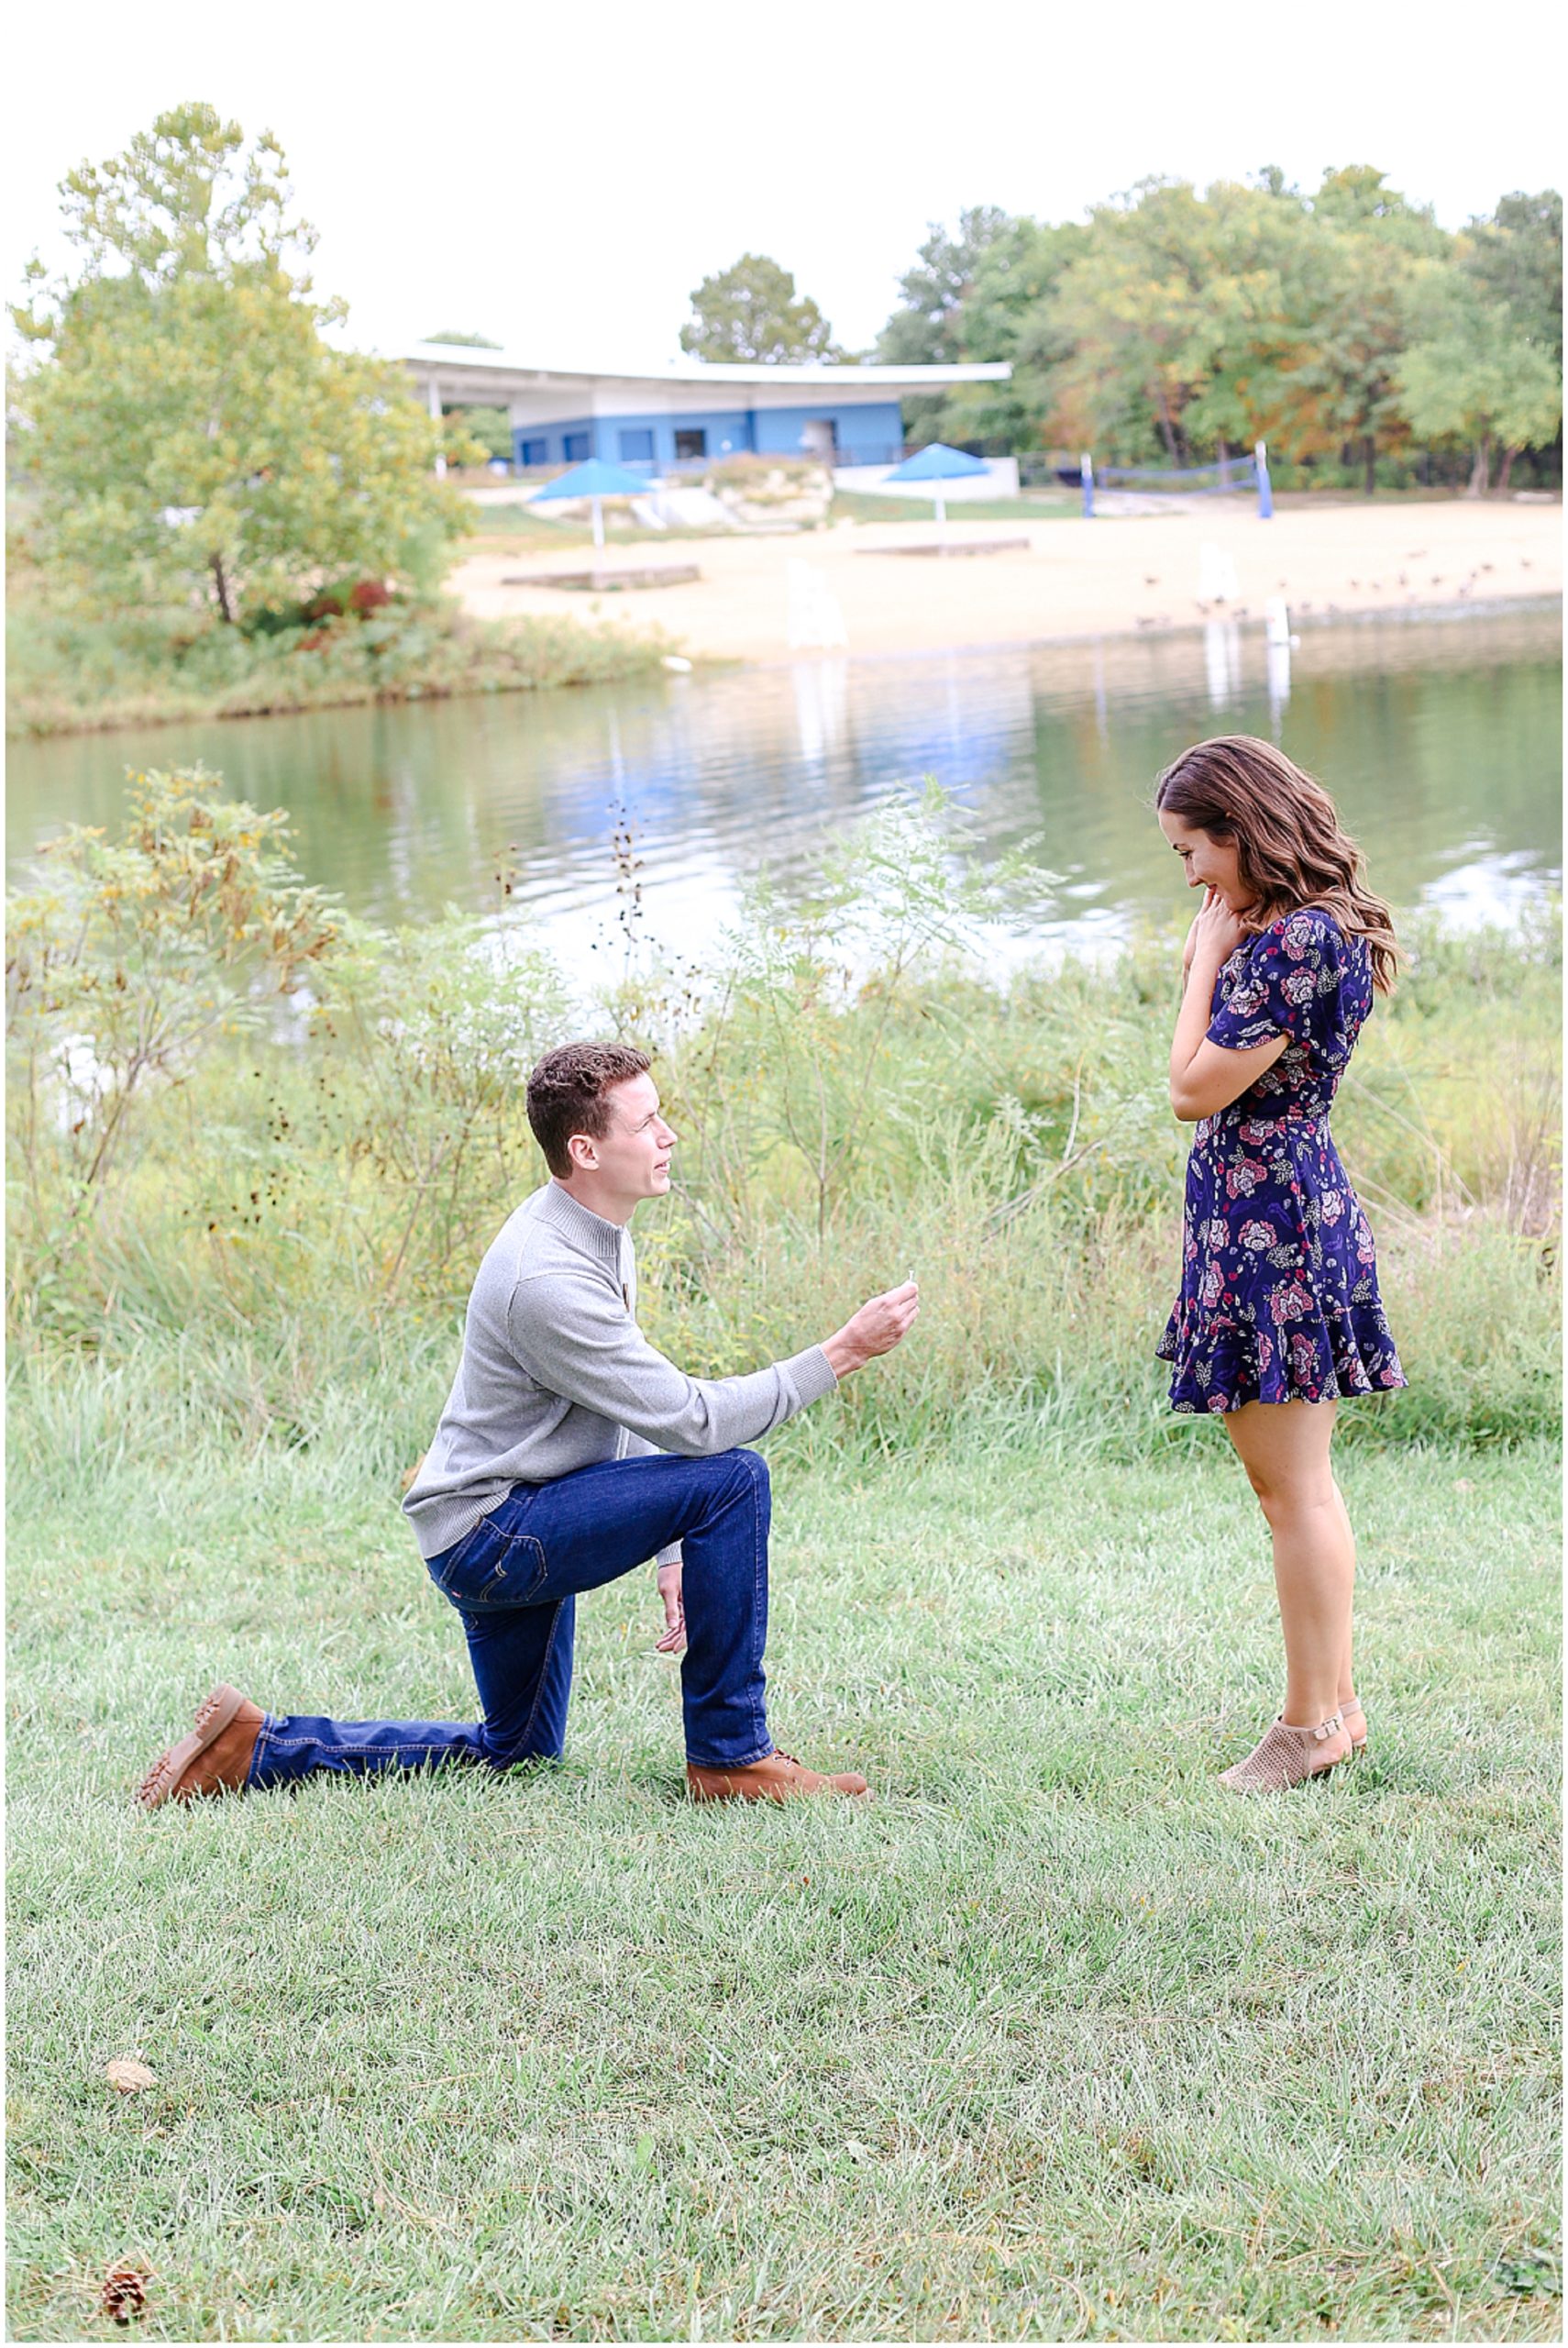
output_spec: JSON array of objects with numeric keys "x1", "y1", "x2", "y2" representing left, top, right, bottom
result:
[{"x1": 9, "y1": 1395, "x2": 1561, "y2": 2341}]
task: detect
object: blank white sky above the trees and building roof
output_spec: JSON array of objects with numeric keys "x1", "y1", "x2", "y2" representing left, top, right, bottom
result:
[{"x1": 0, "y1": 0, "x2": 1561, "y2": 364}]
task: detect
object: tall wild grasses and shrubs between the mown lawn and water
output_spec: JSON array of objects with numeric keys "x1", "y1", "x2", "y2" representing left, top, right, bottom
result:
[{"x1": 9, "y1": 768, "x2": 1561, "y2": 1458}]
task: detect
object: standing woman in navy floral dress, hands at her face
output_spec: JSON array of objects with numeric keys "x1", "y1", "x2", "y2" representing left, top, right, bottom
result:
[{"x1": 1154, "y1": 735, "x2": 1406, "y2": 1794}]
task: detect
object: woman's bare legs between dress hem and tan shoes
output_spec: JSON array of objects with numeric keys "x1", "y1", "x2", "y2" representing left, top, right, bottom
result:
[{"x1": 1223, "y1": 1401, "x2": 1357, "y2": 1749}]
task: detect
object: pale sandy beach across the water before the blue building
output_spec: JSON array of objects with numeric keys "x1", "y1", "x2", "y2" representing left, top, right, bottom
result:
[{"x1": 448, "y1": 500, "x2": 1563, "y2": 662}]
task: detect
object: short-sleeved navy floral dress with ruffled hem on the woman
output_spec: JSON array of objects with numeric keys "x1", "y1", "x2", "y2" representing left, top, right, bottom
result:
[{"x1": 1154, "y1": 906, "x2": 1406, "y2": 1412}]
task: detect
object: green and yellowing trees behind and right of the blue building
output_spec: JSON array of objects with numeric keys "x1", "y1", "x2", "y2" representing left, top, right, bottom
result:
[{"x1": 680, "y1": 164, "x2": 1563, "y2": 493}]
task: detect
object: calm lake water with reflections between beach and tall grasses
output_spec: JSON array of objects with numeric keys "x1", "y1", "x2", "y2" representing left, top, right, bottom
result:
[{"x1": 7, "y1": 605, "x2": 1561, "y2": 963}]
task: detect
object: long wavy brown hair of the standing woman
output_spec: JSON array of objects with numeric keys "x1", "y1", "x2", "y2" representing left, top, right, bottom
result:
[{"x1": 1154, "y1": 735, "x2": 1399, "y2": 995}]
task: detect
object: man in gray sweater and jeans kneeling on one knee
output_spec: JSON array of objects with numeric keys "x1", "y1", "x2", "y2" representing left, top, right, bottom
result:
[{"x1": 138, "y1": 1043, "x2": 920, "y2": 1811}]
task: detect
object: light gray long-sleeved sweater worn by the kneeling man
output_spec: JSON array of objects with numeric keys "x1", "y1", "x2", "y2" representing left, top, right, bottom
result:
[{"x1": 403, "y1": 1181, "x2": 838, "y2": 1556}]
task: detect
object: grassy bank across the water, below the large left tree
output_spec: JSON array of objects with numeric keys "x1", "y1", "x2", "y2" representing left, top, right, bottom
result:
[{"x1": 7, "y1": 587, "x2": 667, "y2": 735}]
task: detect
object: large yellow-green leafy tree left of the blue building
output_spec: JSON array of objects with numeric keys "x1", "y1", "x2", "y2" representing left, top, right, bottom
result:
[{"x1": 12, "y1": 104, "x2": 460, "y2": 622}]
